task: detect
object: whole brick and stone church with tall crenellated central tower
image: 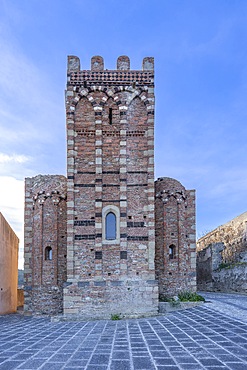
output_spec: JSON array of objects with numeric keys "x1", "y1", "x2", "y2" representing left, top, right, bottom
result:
[{"x1": 24, "y1": 56, "x2": 196, "y2": 319}]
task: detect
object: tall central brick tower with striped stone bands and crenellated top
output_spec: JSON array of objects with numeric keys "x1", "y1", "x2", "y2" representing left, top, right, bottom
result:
[{"x1": 64, "y1": 56, "x2": 158, "y2": 317}]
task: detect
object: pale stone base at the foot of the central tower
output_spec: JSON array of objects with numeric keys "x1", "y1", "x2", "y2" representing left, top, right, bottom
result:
[{"x1": 63, "y1": 279, "x2": 158, "y2": 320}]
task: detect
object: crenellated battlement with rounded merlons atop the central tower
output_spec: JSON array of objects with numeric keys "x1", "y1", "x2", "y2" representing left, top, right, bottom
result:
[{"x1": 67, "y1": 55, "x2": 154, "y2": 86}]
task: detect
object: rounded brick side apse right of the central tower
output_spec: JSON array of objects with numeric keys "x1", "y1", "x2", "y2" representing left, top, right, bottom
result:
[{"x1": 155, "y1": 177, "x2": 196, "y2": 297}]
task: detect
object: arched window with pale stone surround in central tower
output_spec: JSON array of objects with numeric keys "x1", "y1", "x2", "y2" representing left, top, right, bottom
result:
[{"x1": 102, "y1": 205, "x2": 120, "y2": 244}]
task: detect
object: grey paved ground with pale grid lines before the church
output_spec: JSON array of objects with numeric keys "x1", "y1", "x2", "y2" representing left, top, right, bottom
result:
[{"x1": 0, "y1": 303, "x2": 247, "y2": 370}]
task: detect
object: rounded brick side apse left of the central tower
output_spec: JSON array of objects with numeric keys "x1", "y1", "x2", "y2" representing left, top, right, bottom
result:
[{"x1": 24, "y1": 175, "x2": 67, "y2": 314}]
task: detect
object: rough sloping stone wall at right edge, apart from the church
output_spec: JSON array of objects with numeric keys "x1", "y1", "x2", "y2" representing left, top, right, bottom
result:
[{"x1": 197, "y1": 212, "x2": 247, "y2": 293}]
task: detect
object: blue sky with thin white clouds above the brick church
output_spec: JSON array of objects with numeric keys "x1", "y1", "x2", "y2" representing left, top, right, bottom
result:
[{"x1": 0, "y1": 0, "x2": 247, "y2": 266}]
